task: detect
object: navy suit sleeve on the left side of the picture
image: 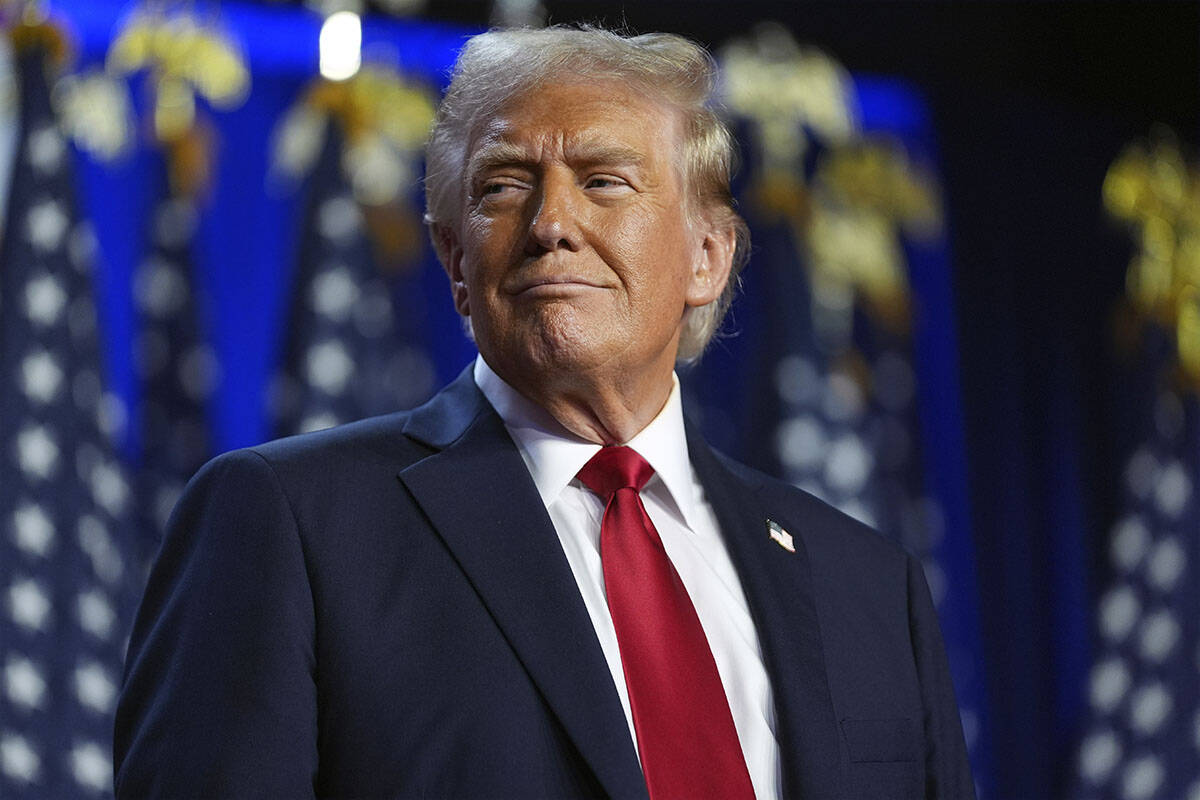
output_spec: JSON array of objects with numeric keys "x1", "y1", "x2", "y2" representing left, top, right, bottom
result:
[{"x1": 114, "y1": 451, "x2": 317, "y2": 798}]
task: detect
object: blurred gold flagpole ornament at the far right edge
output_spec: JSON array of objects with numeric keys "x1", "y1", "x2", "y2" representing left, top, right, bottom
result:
[{"x1": 1103, "y1": 128, "x2": 1200, "y2": 389}]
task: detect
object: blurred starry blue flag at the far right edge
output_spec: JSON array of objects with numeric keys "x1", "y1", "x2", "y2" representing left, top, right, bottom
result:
[{"x1": 1075, "y1": 330, "x2": 1200, "y2": 800}]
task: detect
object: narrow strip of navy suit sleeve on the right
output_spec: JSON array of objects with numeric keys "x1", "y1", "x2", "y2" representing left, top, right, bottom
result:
[{"x1": 908, "y1": 557, "x2": 976, "y2": 800}]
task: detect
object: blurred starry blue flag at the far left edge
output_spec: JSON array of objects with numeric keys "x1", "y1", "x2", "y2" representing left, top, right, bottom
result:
[{"x1": 0, "y1": 47, "x2": 138, "y2": 798}]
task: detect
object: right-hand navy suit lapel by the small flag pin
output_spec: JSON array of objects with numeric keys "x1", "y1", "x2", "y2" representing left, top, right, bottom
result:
[{"x1": 688, "y1": 425, "x2": 844, "y2": 800}]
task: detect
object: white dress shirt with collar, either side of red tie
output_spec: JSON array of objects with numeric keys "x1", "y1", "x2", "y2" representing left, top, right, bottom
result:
[{"x1": 474, "y1": 357, "x2": 781, "y2": 800}]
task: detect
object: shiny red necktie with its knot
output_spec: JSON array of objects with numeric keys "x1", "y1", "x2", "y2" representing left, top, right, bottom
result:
[{"x1": 580, "y1": 447, "x2": 754, "y2": 800}]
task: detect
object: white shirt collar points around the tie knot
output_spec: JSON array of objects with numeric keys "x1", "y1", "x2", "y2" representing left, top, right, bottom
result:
[{"x1": 474, "y1": 356, "x2": 696, "y2": 529}]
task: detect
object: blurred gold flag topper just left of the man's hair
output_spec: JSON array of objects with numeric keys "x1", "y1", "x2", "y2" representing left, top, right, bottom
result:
[{"x1": 274, "y1": 65, "x2": 434, "y2": 267}]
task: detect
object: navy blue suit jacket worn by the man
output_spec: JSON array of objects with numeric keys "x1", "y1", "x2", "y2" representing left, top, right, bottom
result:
[{"x1": 115, "y1": 372, "x2": 973, "y2": 800}]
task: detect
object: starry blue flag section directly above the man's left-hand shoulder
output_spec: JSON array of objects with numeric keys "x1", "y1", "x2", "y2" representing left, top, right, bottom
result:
[{"x1": 271, "y1": 122, "x2": 437, "y2": 435}]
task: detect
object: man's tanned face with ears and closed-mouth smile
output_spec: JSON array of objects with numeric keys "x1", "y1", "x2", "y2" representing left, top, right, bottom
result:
[{"x1": 444, "y1": 82, "x2": 732, "y2": 389}]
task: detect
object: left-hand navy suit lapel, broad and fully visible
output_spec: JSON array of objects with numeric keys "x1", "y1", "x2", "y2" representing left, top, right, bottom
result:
[{"x1": 400, "y1": 372, "x2": 646, "y2": 798}]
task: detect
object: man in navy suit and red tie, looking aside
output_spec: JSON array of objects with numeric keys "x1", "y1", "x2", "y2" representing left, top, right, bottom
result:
[{"x1": 115, "y1": 29, "x2": 973, "y2": 800}]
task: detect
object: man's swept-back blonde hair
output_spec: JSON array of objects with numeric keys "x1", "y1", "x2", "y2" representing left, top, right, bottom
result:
[{"x1": 425, "y1": 26, "x2": 750, "y2": 361}]
